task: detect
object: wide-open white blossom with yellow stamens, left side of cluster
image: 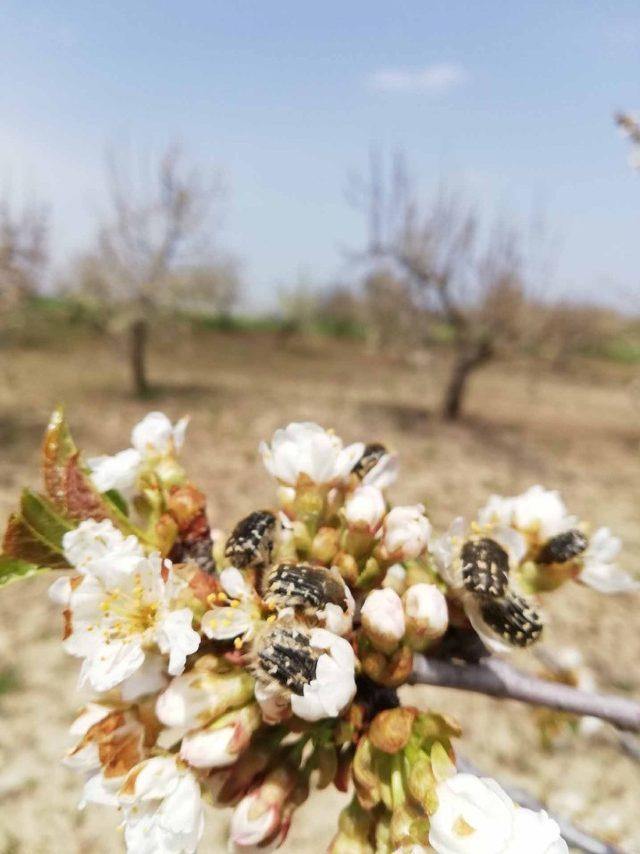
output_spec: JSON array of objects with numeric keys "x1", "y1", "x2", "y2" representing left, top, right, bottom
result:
[{"x1": 64, "y1": 554, "x2": 200, "y2": 691}]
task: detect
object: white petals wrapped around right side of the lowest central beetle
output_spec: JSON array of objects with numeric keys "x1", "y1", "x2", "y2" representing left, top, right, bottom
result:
[{"x1": 291, "y1": 629, "x2": 356, "y2": 721}]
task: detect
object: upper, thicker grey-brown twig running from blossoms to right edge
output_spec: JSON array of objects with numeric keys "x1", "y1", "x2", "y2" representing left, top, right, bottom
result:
[{"x1": 410, "y1": 655, "x2": 640, "y2": 732}]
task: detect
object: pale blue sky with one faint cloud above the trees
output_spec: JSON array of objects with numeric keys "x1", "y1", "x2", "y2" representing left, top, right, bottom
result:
[{"x1": 0, "y1": 0, "x2": 640, "y2": 307}]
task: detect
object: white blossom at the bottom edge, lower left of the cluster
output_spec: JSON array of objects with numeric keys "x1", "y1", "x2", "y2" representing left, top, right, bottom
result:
[{"x1": 118, "y1": 756, "x2": 204, "y2": 854}]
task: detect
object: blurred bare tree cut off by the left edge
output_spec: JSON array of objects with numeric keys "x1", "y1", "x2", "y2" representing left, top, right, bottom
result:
[{"x1": 0, "y1": 198, "x2": 49, "y2": 305}]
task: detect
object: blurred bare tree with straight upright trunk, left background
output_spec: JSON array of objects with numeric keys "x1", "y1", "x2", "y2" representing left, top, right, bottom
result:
[{"x1": 83, "y1": 145, "x2": 235, "y2": 395}]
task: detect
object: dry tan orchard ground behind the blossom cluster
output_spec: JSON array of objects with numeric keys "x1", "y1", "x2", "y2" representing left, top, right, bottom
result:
[{"x1": 0, "y1": 333, "x2": 640, "y2": 854}]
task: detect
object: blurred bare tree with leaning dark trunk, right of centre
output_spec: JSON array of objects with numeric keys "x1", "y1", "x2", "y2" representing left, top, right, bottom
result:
[{"x1": 353, "y1": 155, "x2": 525, "y2": 419}]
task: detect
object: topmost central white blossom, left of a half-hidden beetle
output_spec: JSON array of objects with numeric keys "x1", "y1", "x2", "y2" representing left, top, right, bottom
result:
[{"x1": 260, "y1": 421, "x2": 364, "y2": 487}]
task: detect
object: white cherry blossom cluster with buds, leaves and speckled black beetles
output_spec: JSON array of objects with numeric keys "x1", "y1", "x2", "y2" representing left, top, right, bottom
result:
[{"x1": 0, "y1": 412, "x2": 637, "y2": 854}]
